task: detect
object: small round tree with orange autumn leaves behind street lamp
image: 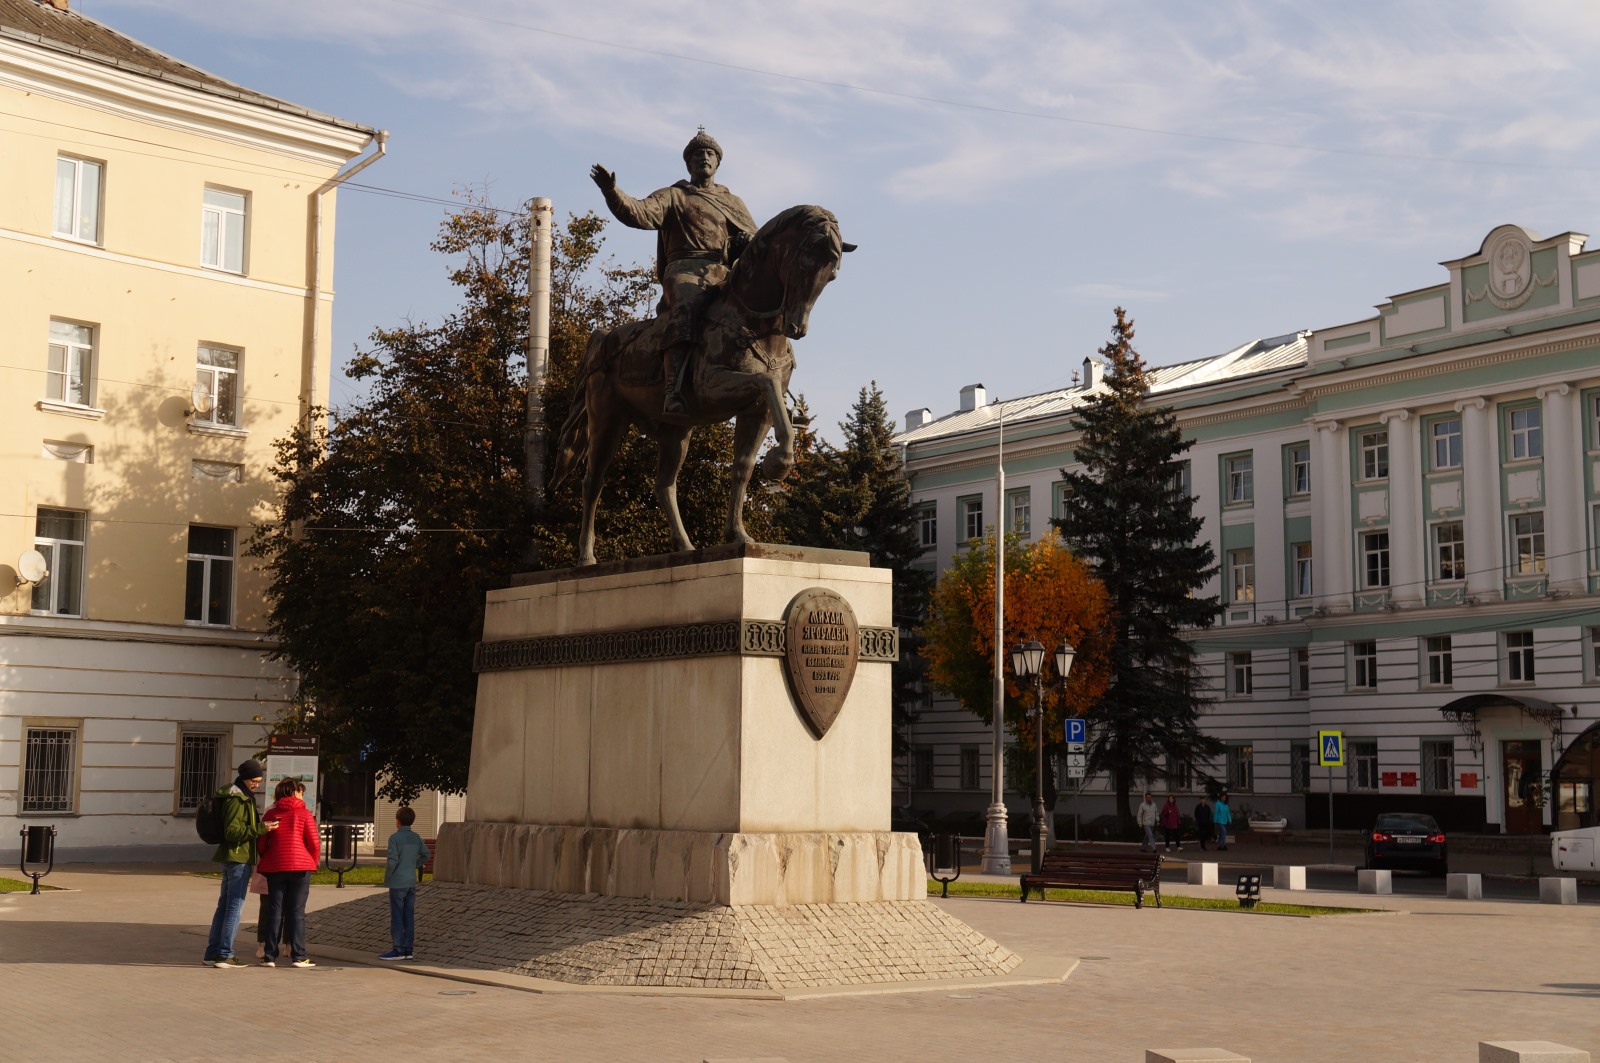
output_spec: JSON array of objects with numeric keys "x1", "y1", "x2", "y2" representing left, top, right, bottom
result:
[{"x1": 922, "y1": 533, "x2": 1114, "y2": 807}]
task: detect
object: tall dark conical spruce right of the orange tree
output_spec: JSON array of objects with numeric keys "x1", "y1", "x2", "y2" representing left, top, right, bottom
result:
[{"x1": 1054, "y1": 306, "x2": 1222, "y2": 829}]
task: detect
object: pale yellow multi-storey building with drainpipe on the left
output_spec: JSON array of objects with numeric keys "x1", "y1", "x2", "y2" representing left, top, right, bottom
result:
[{"x1": 0, "y1": 0, "x2": 384, "y2": 861}]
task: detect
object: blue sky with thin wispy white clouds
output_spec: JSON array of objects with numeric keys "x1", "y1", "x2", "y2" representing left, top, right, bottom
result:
[{"x1": 81, "y1": 0, "x2": 1600, "y2": 442}]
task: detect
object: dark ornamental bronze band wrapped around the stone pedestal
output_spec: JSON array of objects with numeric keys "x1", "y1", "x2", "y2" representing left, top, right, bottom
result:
[{"x1": 472, "y1": 620, "x2": 899, "y2": 672}]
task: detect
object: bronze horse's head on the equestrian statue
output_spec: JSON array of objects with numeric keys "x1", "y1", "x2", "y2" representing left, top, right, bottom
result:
[{"x1": 730, "y1": 205, "x2": 856, "y2": 339}]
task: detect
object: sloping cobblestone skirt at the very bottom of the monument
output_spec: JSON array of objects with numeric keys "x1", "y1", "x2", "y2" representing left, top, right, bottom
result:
[{"x1": 307, "y1": 882, "x2": 1017, "y2": 996}]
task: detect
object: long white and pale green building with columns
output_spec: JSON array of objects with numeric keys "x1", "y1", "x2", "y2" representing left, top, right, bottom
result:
[{"x1": 899, "y1": 226, "x2": 1600, "y2": 832}]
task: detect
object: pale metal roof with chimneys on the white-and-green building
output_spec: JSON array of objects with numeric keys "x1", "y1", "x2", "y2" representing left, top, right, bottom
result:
[{"x1": 894, "y1": 333, "x2": 1309, "y2": 443}]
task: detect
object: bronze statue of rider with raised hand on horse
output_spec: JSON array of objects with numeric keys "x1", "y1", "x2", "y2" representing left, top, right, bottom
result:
[{"x1": 550, "y1": 130, "x2": 856, "y2": 565}]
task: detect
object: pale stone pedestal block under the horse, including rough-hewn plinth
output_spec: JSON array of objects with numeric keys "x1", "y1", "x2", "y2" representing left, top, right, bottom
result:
[{"x1": 437, "y1": 544, "x2": 926, "y2": 905}]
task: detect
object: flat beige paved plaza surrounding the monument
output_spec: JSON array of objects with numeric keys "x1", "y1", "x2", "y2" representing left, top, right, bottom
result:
[{"x1": 0, "y1": 866, "x2": 1600, "y2": 1063}]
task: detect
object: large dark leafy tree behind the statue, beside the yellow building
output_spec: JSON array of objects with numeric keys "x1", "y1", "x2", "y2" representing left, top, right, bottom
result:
[{"x1": 250, "y1": 199, "x2": 748, "y2": 797}]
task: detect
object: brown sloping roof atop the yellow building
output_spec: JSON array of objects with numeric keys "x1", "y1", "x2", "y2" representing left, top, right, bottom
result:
[{"x1": 0, "y1": 0, "x2": 374, "y2": 134}]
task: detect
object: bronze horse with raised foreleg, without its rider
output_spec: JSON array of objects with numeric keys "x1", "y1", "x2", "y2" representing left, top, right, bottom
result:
[{"x1": 550, "y1": 207, "x2": 856, "y2": 565}]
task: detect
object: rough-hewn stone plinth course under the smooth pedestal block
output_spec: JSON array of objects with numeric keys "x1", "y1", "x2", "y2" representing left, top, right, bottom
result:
[{"x1": 434, "y1": 823, "x2": 928, "y2": 906}]
